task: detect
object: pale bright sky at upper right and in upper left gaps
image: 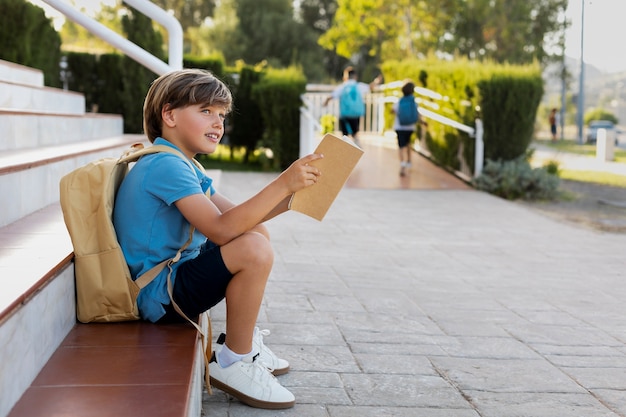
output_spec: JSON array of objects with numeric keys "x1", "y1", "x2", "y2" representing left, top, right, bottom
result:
[{"x1": 30, "y1": 0, "x2": 626, "y2": 72}]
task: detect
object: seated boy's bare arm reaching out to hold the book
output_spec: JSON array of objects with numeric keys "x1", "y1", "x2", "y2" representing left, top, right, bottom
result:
[{"x1": 175, "y1": 154, "x2": 321, "y2": 246}]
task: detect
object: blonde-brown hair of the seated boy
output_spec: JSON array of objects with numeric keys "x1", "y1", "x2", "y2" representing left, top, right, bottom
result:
[{"x1": 143, "y1": 69, "x2": 233, "y2": 142}]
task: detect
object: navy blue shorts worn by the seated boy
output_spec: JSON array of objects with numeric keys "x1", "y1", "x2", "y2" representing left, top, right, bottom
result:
[{"x1": 159, "y1": 240, "x2": 233, "y2": 323}]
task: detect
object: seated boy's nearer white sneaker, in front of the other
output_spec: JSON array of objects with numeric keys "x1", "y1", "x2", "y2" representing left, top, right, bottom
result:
[{"x1": 209, "y1": 354, "x2": 296, "y2": 410}]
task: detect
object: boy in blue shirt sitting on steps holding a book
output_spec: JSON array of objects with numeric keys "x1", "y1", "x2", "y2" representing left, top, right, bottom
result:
[{"x1": 113, "y1": 69, "x2": 322, "y2": 408}]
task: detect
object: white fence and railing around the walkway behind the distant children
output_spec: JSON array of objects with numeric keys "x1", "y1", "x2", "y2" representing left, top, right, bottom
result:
[{"x1": 300, "y1": 82, "x2": 484, "y2": 177}]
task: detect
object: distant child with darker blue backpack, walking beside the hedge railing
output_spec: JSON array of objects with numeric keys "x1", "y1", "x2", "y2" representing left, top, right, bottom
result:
[{"x1": 392, "y1": 81, "x2": 420, "y2": 176}]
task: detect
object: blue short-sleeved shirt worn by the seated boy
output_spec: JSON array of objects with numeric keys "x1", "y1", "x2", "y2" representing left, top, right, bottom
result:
[{"x1": 113, "y1": 138, "x2": 215, "y2": 322}]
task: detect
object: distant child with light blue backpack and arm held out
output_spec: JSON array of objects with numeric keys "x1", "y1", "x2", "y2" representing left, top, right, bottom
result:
[{"x1": 324, "y1": 66, "x2": 382, "y2": 146}]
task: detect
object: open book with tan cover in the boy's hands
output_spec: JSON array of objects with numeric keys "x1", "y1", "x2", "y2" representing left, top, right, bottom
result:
[{"x1": 289, "y1": 134, "x2": 363, "y2": 221}]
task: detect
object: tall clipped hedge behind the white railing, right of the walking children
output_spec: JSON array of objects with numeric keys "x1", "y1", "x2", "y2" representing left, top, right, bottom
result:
[{"x1": 383, "y1": 60, "x2": 543, "y2": 171}]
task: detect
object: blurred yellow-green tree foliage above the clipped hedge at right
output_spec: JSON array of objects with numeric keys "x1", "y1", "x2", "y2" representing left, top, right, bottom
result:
[{"x1": 319, "y1": 0, "x2": 567, "y2": 69}]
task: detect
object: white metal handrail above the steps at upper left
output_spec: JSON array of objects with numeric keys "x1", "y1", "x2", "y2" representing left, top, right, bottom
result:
[{"x1": 43, "y1": 0, "x2": 183, "y2": 75}]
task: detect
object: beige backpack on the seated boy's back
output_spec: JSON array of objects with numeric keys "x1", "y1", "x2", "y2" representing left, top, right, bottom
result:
[{"x1": 60, "y1": 144, "x2": 195, "y2": 323}]
